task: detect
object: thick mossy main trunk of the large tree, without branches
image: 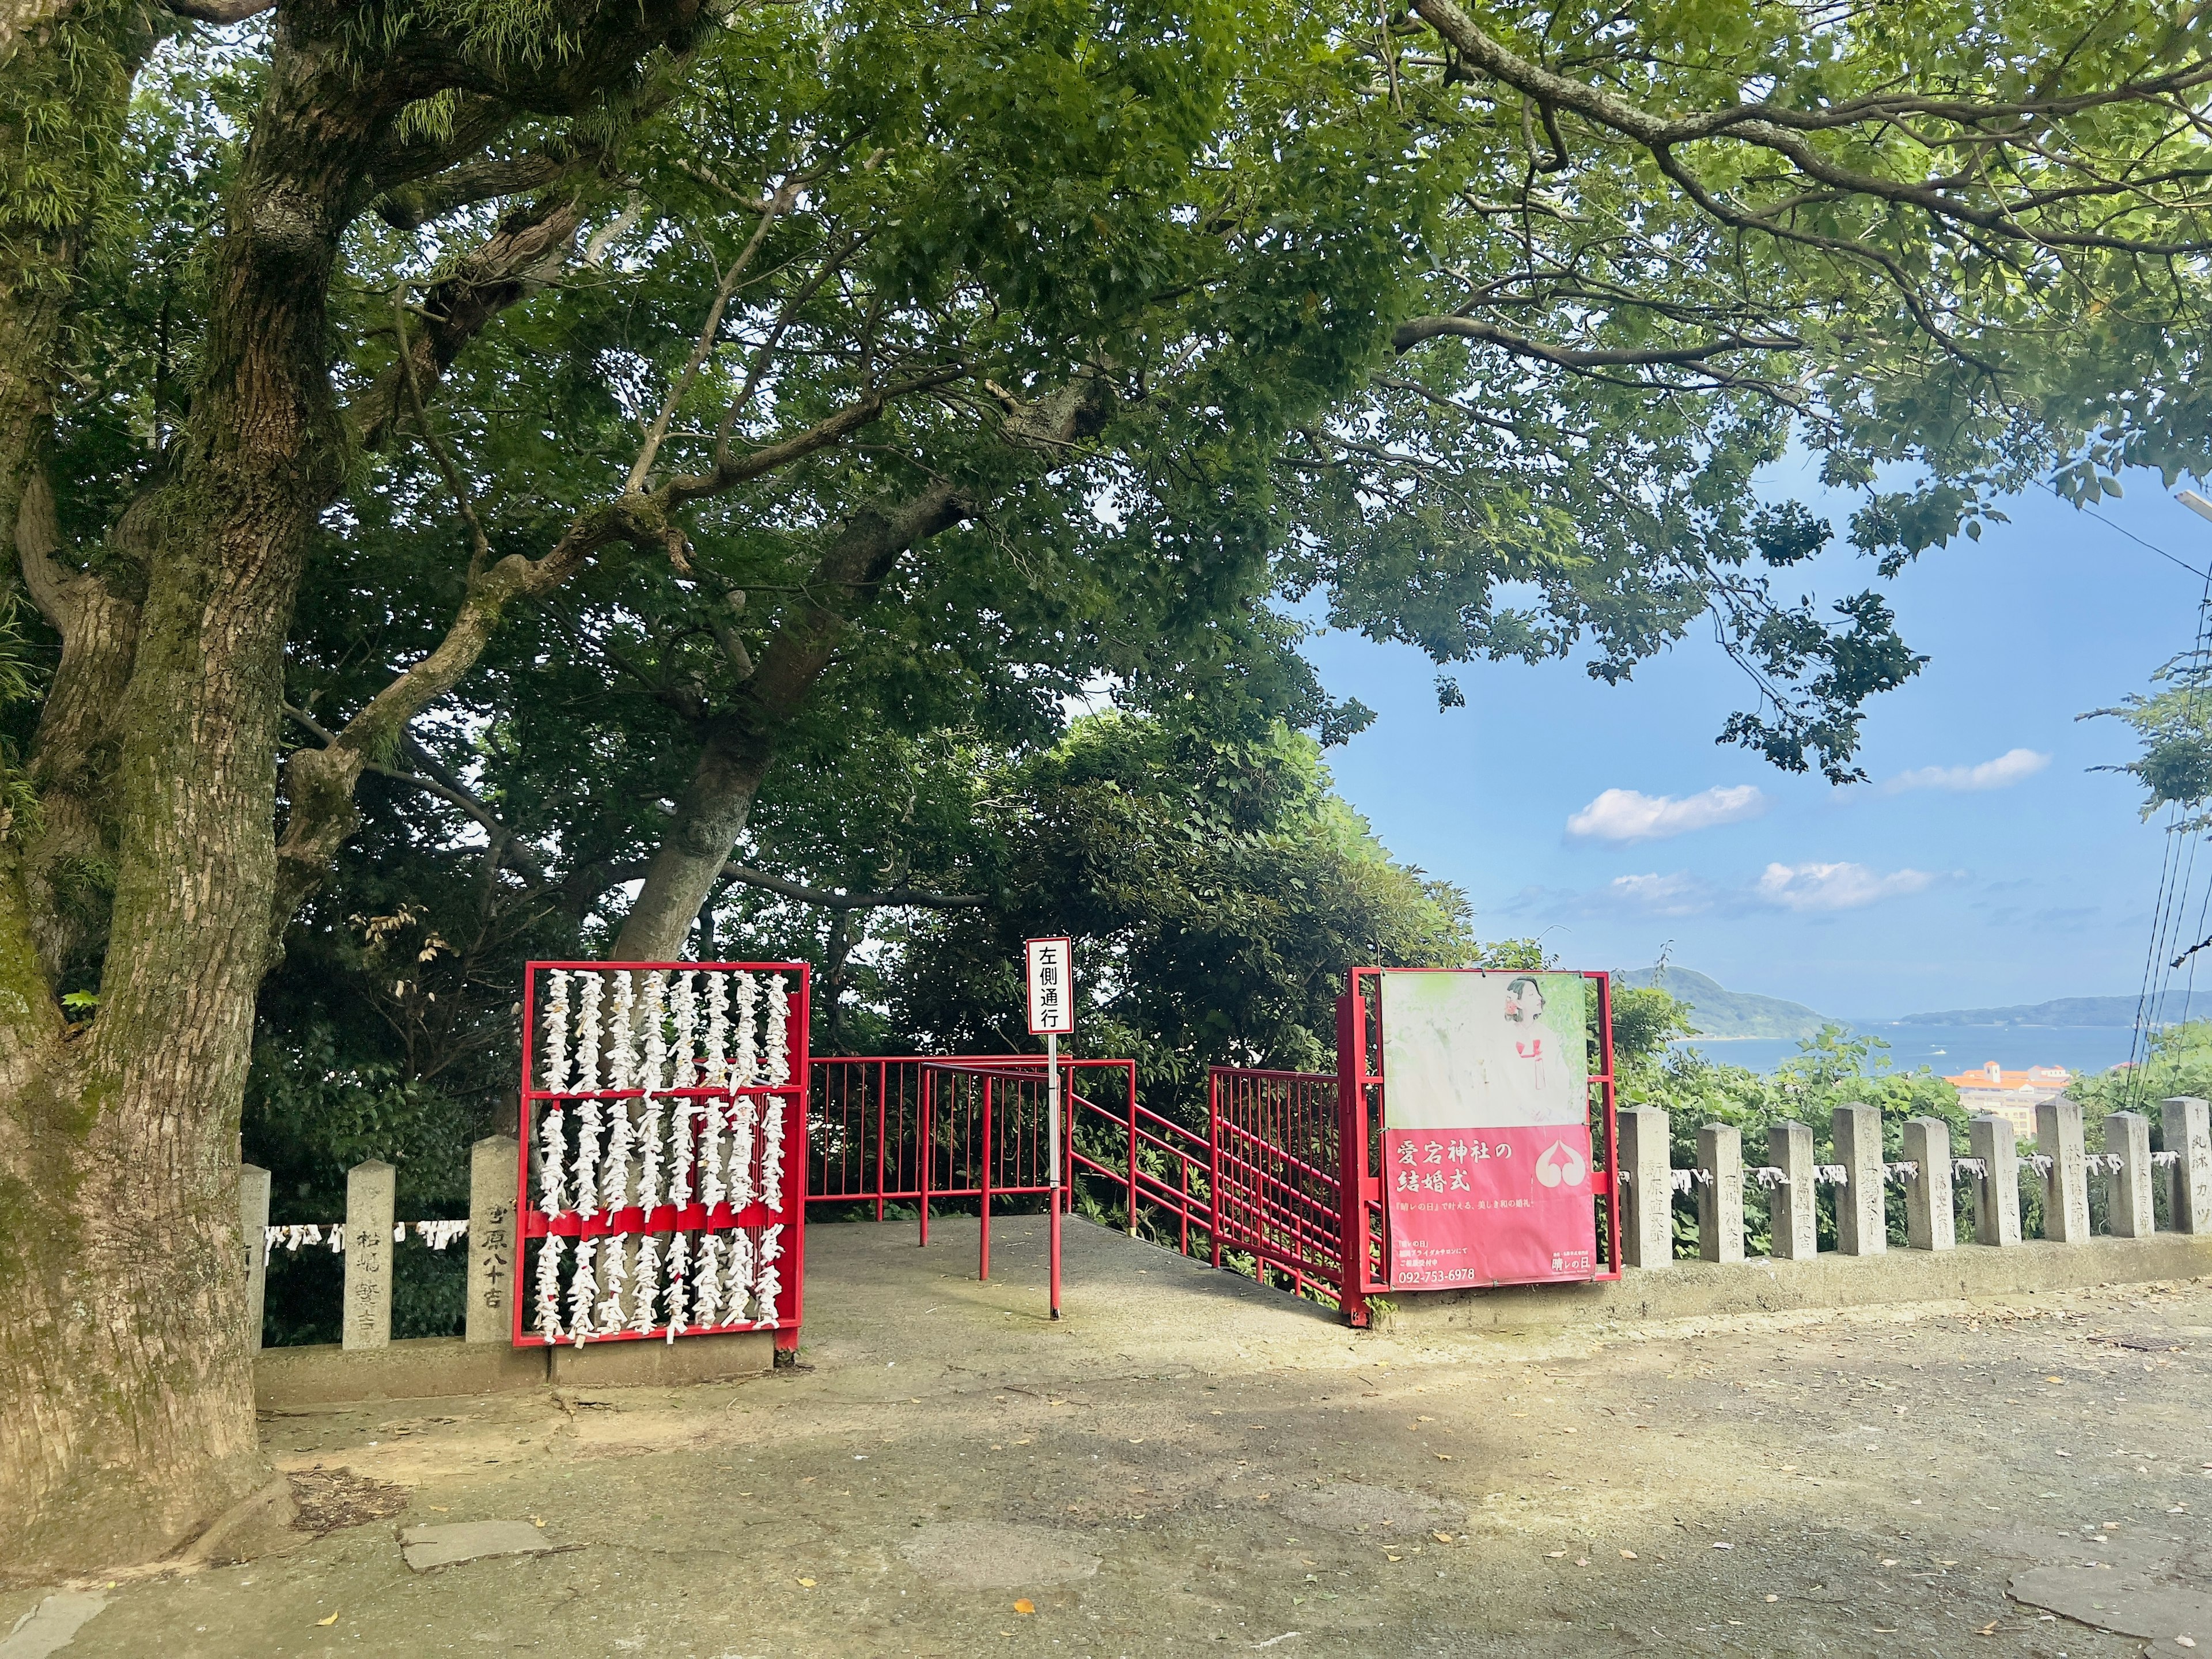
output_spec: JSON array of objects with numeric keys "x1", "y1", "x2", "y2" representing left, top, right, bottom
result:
[{"x1": 0, "y1": 13, "x2": 382, "y2": 1569}]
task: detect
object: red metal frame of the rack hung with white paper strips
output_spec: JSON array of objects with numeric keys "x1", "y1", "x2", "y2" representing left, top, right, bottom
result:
[{"x1": 513, "y1": 962, "x2": 812, "y2": 1349}]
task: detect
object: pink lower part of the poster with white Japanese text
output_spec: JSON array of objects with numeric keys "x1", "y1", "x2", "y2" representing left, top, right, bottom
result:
[{"x1": 1382, "y1": 1124, "x2": 1597, "y2": 1290}]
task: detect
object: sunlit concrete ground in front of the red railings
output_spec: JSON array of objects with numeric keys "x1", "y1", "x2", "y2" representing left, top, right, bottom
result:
[{"x1": 0, "y1": 1219, "x2": 2212, "y2": 1659}]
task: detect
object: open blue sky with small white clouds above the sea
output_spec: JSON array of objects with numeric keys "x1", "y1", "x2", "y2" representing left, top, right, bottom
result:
[{"x1": 1307, "y1": 471, "x2": 2212, "y2": 1017}]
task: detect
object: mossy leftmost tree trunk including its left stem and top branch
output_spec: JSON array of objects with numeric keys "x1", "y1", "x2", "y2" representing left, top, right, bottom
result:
[{"x1": 0, "y1": 2, "x2": 697, "y2": 1573}]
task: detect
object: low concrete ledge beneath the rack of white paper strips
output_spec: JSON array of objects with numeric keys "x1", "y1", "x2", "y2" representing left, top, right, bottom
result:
[{"x1": 255, "y1": 1332, "x2": 777, "y2": 1411}]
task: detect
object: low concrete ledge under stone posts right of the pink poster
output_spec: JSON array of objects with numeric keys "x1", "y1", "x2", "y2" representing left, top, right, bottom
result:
[{"x1": 1376, "y1": 1232, "x2": 2212, "y2": 1336}]
